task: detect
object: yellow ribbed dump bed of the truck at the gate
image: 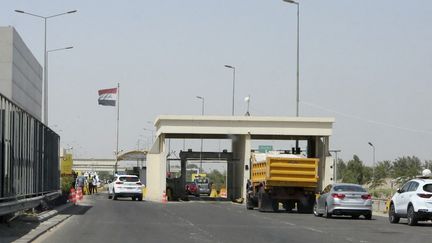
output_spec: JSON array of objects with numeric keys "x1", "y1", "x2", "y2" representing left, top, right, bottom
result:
[{"x1": 251, "y1": 153, "x2": 319, "y2": 188}]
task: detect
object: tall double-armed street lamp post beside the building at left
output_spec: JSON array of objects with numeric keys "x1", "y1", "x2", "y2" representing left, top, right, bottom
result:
[{"x1": 15, "y1": 10, "x2": 77, "y2": 125}]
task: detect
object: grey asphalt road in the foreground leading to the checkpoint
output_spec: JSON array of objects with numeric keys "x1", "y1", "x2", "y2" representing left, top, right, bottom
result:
[{"x1": 36, "y1": 194, "x2": 432, "y2": 243}]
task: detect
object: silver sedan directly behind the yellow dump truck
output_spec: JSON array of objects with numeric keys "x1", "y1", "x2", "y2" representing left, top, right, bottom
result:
[{"x1": 314, "y1": 183, "x2": 372, "y2": 219}]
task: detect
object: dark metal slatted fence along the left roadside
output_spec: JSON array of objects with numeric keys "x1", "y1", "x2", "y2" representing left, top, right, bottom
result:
[{"x1": 0, "y1": 94, "x2": 60, "y2": 204}]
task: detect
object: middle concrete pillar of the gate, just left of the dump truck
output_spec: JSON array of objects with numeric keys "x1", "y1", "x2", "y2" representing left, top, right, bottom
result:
[{"x1": 228, "y1": 134, "x2": 251, "y2": 200}]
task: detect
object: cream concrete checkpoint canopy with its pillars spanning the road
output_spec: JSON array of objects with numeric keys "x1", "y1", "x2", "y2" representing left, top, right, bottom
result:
[{"x1": 146, "y1": 115, "x2": 335, "y2": 201}]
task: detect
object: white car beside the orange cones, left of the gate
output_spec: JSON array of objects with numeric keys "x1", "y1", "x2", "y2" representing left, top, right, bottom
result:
[{"x1": 108, "y1": 175, "x2": 143, "y2": 201}]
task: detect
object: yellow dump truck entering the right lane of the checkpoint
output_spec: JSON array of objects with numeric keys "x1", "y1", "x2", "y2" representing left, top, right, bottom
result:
[{"x1": 246, "y1": 153, "x2": 319, "y2": 213}]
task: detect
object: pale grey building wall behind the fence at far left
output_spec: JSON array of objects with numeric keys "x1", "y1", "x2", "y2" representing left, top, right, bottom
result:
[{"x1": 0, "y1": 26, "x2": 43, "y2": 120}]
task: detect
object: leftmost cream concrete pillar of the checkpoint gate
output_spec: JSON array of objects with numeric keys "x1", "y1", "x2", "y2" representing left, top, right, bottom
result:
[{"x1": 146, "y1": 135, "x2": 167, "y2": 202}]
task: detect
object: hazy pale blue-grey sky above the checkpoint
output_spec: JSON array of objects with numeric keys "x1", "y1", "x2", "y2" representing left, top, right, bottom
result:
[{"x1": 0, "y1": 0, "x2": 432, "y2": 163}]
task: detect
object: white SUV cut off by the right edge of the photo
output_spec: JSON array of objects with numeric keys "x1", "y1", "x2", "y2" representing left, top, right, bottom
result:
[{"x1": 389, "y1": 179, "x2": 432, "y2": 226}]
